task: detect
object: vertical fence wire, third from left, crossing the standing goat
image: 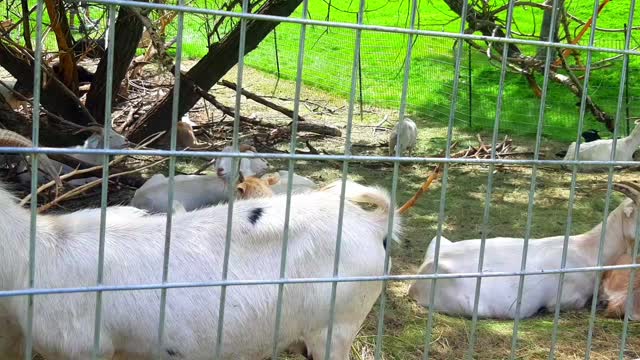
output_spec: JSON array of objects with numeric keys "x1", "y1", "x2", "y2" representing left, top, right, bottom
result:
[{"x1": 157, "y1": 0, "x2": 188, "y2": 356}]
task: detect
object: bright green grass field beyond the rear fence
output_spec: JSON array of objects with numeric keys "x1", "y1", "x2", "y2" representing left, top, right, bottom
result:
[{"x1": 5, "y1": 0, "x2": 640, "y2": 141}]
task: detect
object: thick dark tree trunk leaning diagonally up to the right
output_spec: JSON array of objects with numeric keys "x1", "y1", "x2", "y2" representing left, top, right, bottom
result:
[{"x1": 127, "y1": 0, "x2": 302, "y2": 142}]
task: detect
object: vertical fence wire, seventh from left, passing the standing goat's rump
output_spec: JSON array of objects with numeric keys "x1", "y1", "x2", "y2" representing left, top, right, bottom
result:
[{"x1": 372, "y1": 0, "x2": 419, "y2": 359}]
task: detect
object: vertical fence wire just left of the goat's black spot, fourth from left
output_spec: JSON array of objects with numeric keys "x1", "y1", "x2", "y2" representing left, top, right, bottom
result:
[{"x1": 214, "y1": 0, "x2": 249, "y2": 360}]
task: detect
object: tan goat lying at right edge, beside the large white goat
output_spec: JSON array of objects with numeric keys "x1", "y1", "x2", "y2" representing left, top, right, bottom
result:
[{"x1": 600, "y1": 254, "x2": 640, "y2": 320}]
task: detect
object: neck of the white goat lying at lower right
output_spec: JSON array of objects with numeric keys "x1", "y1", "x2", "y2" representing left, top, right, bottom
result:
[{"x1": 582, "y1": 208, "x2": 627, "y2": 264}]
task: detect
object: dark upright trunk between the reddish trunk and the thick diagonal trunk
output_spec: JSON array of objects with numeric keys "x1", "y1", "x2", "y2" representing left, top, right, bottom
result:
[{"x1": 86, "y1": 1, "x2": 146, "y2": 124}]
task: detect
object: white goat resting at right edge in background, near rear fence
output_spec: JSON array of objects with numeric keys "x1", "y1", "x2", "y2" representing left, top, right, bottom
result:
[{"x1": 564, "y1": 120, "x2": 640, "y2": 169}]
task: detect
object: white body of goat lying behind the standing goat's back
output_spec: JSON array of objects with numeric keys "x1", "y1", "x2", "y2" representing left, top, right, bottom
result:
[{"x1": 130, "y1": 174, "x2": 228, "y2": 213}]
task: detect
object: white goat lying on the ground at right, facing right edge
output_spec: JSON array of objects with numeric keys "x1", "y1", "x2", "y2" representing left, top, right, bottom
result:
[{"x1": 409, "y1": 183, "x2": 640, "y2": 318}]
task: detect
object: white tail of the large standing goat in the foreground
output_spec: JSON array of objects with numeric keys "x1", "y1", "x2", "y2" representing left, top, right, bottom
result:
[{"x1": 320, "y1": 180, "x2": 401, "y2": 241}]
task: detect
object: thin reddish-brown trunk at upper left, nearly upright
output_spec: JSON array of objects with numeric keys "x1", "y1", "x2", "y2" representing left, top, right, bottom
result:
[{"x1": 44, "y1": 0, "x2": 78, "y2": 94}]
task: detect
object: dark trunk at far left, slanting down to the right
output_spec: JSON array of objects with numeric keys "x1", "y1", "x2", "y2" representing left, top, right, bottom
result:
[{"x1": 0, "y1": 37, "x2": 92, "y2": 125}]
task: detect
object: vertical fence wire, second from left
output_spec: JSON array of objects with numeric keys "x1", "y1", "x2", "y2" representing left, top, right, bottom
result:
[{"x1": 91, "y1": 5, "x2": 116, "y2": 360}]
